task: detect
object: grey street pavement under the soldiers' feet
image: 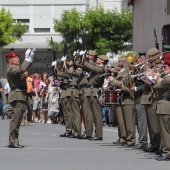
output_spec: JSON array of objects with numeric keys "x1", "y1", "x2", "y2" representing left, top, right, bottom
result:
[{"x1": 0, "y1": 119, "x2": 170, "y2": 170}]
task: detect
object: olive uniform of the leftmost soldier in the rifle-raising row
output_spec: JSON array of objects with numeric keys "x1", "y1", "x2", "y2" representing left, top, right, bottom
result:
[{"x1": 56, "y1": 71, "x2": 73, "y2": 137}]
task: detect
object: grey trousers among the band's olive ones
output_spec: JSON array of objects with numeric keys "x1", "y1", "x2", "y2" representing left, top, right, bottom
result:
[{"x1": 135, "y1": 104, "x2": 148, "y2": 145}]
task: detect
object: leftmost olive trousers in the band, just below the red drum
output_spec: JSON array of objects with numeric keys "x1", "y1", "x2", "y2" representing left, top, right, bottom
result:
[{"x1": 114, "y1": 105, "x2": 126, "y2": 142}]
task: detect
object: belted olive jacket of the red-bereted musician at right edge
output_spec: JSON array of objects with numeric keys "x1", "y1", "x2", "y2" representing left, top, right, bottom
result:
[{"x1": 153, "y1": 76, "x2": 170, "y2": 115}]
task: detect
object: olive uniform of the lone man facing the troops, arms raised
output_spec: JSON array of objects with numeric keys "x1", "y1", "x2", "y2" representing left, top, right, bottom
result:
[{"x1": 6, "y1": 61, "x2": 30, "y2": 145}]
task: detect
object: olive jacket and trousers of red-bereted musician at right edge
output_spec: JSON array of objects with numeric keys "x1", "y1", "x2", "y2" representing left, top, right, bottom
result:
[{"x1": 153, "y1": 75, "x2": 170, "y2": 159}]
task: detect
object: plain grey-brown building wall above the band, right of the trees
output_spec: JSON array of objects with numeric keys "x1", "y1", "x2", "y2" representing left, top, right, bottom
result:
[{"x1": 133, "y1": 0, "x2": 170, "y2": 51}]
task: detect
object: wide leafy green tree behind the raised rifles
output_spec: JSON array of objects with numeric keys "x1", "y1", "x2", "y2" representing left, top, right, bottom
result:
[{"x1": 54, "y1": 8, "x2": 132, "y2": 54}]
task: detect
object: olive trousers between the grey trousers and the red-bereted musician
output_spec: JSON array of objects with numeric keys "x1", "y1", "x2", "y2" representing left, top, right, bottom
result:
[{"x1": 145, "y1": 105, "x2": 160, "y2": 148}]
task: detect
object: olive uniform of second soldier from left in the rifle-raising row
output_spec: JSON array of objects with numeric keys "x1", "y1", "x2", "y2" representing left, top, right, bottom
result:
[{"x1": 65, "y1": 69, "x2": 81, "y2": 138}]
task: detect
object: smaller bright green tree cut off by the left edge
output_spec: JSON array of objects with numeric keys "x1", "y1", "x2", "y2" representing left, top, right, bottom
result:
[{"x1": 0, "y1": 8, "x2": 27, "y2": 47}]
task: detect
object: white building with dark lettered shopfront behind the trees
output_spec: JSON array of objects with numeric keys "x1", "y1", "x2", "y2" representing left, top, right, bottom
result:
[{"x1": 0, "y1": 0, "x2": 127, "y2": 78}]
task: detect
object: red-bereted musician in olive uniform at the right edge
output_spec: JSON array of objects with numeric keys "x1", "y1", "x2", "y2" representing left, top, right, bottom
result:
[{"x1": 153, "y1": 53, "x2": 170, "y2": 161}]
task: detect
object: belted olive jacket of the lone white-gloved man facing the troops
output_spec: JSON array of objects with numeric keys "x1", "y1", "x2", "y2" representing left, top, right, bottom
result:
[{"x1": 6, "y1": 60, "x2": 31, "y2": 103}]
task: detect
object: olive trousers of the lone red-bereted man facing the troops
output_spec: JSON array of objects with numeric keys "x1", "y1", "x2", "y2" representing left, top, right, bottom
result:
[{"x1": 9, "y1": 100, "x2": 27, "y2": 145}]
